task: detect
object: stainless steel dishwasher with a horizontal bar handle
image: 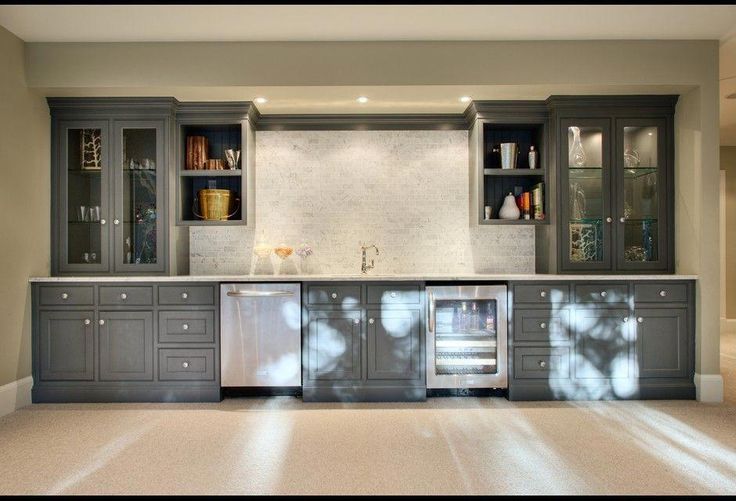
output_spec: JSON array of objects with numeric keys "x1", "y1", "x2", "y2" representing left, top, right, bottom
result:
[{"x1": 220, "y1": 283, "x2": 302, "y2": 387}]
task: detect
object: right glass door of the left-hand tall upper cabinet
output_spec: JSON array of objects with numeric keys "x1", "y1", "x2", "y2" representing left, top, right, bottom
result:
[{"x1": 113, "y1": 121, "x2": 166, "y2": 272}]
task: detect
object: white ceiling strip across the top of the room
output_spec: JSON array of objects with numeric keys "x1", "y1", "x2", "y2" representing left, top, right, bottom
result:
[{"x1": 0, "y1": 5, "x2": 736, "y2": 42}]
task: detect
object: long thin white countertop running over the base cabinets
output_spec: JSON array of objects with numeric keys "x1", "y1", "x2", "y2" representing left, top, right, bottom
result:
[{"x1": 29, "y1": 273, "x2": 698, "y2": 282}]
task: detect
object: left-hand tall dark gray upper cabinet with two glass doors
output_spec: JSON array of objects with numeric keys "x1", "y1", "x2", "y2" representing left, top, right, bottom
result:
[{"x1": 48, "y1": 98, "x2": 174, "y2": 274}]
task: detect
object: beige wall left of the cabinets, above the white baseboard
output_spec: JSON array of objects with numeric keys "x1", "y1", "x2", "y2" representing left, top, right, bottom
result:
[{"x1": 0, "y1": 27, "x2": 50, "y2": 386}]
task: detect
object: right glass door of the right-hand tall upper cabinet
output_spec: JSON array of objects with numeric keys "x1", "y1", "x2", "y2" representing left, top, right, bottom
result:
[{"x1": 616, "y1": 119, "x2": 667, "y2": 270}]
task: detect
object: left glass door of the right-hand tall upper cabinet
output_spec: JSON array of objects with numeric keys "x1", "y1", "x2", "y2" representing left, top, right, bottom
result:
[{"x1": 559, "y1": 119, "x2": 613, "y2": 270}]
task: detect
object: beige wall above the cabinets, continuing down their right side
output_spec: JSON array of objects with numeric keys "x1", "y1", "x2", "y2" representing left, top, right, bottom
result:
[{"x1": 15, "y1": 41, "x2": 720, "y2": 394}]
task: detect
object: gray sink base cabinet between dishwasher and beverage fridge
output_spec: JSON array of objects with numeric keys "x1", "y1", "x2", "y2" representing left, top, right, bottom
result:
[{"x1": 302, "y1": 282, "x2": 427, "y2": 401}]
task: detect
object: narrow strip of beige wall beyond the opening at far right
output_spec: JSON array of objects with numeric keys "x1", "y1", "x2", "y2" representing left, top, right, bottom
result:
[{"x1": 721, "y1": 146, "x2": 736, "y2": 318}]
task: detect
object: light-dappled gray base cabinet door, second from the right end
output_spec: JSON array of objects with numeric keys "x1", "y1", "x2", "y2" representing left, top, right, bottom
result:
[{"x1": 574, "y1": 308, "x2": 635, "y2": 380}]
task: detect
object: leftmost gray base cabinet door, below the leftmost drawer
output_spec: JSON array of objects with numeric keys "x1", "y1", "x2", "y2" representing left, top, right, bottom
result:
[{"x1": 38, "y1": 311, "x2": 95, "y2": 381}]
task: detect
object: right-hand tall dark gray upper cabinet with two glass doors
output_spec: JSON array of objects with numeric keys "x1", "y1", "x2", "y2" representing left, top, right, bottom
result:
[{"x1": 548, "y1": 96, "x2": 677, "y2": 273}]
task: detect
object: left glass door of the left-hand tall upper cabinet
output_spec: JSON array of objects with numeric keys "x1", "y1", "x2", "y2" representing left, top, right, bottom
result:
[{"x1": 57, "y1": 121, "x2": 110, "y2": 272}]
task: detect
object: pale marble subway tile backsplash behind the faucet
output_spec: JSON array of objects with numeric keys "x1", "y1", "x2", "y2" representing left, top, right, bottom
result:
[{"x1": 189, "y1": 131, "x2": 534, "y2": 275}]
